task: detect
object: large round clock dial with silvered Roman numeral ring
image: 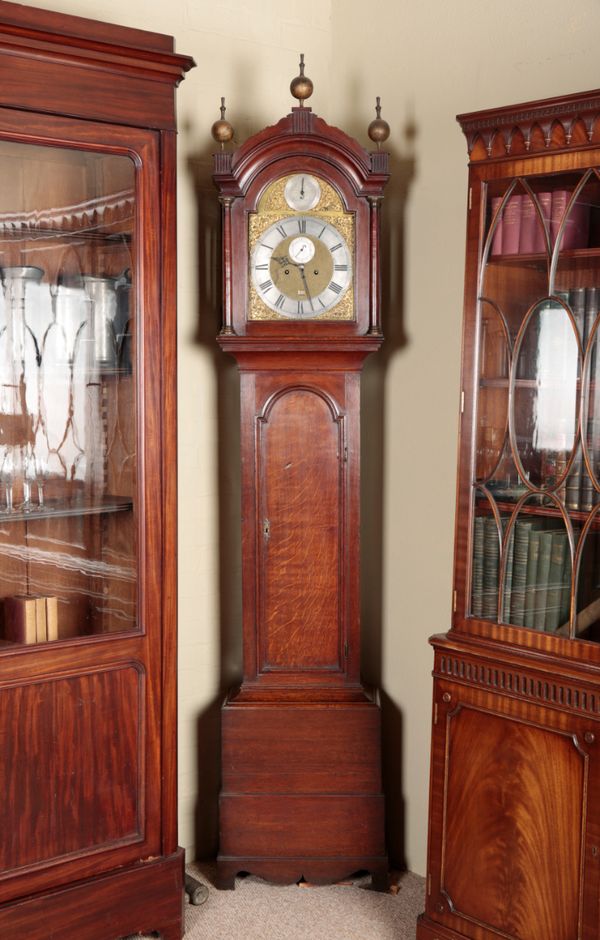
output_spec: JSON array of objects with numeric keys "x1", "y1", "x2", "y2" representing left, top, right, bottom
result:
[{"x1": 250, "y1": 214, "x2": 352, "y2": 320}]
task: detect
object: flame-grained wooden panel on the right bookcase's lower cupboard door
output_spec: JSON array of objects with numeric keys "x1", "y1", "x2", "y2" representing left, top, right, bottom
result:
[{"x1": 442, "y1": 707, "x2": 586, "y2": 940}]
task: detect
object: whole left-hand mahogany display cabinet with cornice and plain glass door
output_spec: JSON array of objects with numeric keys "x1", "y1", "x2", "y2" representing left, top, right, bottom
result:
[{"x1": 0, "y1": 2, "x2": 193, "y2": 940}]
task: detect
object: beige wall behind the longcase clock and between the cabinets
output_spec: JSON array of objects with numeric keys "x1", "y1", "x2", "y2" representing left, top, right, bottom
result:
[{"x1": 23, "y1": 0, "x2": 600, "y2": 873}]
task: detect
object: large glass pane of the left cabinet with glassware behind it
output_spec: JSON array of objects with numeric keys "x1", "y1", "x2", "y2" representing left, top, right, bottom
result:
[{"x1": 0, "y1": 141, "x2": 137, "y2": 645}]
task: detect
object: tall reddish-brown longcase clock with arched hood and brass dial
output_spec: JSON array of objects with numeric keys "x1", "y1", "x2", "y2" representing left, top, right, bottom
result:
[{"x1": 214, "y1": 68, "x2": 388, "y2": 887}]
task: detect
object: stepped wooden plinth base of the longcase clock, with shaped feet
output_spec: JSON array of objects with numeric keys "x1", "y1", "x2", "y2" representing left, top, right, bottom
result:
[{"x1": 218, "y1": 693, "x2": 387, "y2": 887}]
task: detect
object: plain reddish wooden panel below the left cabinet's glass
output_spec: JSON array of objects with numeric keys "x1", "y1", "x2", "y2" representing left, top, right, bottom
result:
[{"x1": 0, "y1": 664, "x2": 143, "y2": 877}]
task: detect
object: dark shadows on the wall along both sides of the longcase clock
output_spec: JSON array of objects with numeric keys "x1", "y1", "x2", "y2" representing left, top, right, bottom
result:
[{"x1": 186, "y1": 114, "x2": 415, "y2": 868}]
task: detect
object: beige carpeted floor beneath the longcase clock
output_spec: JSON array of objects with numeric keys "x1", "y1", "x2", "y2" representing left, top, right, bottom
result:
[{"x1": 128, "y1": 865, "x2": 425, "y2": 940}]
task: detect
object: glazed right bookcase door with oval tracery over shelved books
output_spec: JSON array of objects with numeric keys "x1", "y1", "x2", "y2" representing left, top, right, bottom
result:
[{"x1": 467, "y1": 165, "x2": 600, "y2": 642}]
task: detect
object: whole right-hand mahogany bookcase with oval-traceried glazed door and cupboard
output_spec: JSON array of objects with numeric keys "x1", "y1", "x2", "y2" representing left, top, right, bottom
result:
[{"x1": 417, "y1": 91, "x2": 600, "y2": 940}]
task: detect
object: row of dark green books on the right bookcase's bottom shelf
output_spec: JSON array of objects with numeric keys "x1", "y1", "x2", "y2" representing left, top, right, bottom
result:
[{"x1": 471, "y1": 516, "x2": 571, "y2": 632}]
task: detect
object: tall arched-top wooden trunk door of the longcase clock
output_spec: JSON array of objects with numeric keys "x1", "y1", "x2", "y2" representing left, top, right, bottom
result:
[{"x1": 258, "y1": 387, "x2": 343, "y2": 670}]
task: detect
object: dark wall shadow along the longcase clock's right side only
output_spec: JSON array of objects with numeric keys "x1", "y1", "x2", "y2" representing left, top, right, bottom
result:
[{"x1": 358, "y1": 121, "x2": 416, "y2": 869}]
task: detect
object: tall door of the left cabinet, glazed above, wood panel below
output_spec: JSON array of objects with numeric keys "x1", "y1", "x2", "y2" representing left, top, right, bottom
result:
[{"x1": 0, "y1": 106, "x2": 162, "y2": 902}]
